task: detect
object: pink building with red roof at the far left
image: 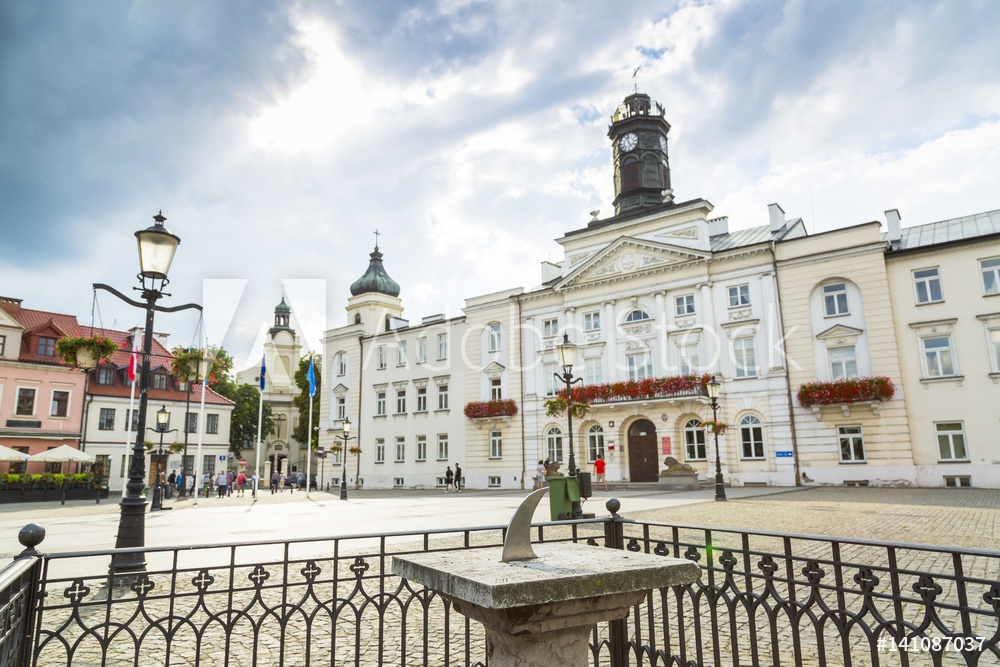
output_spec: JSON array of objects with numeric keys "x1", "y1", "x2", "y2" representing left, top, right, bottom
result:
[{"x1": 0, "y1": 297, "x2": 85, "y2": 474}]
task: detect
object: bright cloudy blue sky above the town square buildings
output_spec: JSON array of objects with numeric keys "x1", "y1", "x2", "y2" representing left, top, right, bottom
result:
[{"x1": 0, "y1": 0, "x2": 1000, "y2": 367}]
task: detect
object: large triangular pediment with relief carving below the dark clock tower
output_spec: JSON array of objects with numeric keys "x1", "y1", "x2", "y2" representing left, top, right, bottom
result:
[{"x1": 555, "y1": 236, "x2": 709, "y2": 289}]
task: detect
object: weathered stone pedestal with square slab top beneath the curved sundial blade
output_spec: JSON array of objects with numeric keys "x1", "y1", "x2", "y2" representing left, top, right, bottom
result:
[{"x1": 392, "y1": 544, "x2": 700, "y2": 667}]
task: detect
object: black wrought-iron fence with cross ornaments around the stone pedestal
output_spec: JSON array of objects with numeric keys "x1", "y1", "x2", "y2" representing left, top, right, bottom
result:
[{"x1": 0, "y1": 501, "x2": 1000, "y2": 667}]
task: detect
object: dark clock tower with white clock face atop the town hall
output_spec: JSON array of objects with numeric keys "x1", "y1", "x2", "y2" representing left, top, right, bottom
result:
[{"x1": 608, "y1": 92, "x2": 674, "y2": 215}]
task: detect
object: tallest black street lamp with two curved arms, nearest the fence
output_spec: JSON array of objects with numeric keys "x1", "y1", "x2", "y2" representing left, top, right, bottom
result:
[{"x1": 94, "y1": 211, "x2": 201, "y2": 574}]
